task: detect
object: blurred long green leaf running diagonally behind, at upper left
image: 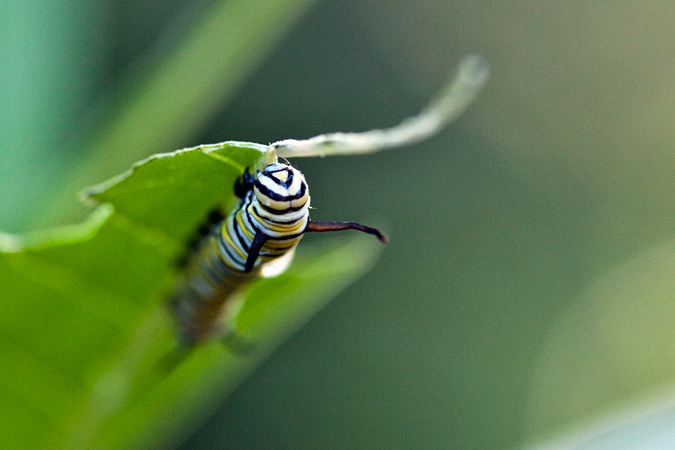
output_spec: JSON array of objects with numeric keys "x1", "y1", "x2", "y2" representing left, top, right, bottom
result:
[{"x1": 41, "y1": 0, "x2": 314, "y2": 229}]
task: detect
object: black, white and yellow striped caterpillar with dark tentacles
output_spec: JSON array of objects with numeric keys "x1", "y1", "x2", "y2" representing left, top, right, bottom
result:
[{"x1": 170, "y1": 164, "x2": 386, "y2": 349}]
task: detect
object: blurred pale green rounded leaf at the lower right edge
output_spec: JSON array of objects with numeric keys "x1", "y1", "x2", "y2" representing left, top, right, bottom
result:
[{"x1": 527, "y1": 239, "x2": 675, "y2": 442}]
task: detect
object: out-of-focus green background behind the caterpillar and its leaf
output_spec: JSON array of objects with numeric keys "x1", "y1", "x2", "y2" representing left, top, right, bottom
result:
[{"x1": 6, "y1": 0, "x2": 675, "y2": 450}]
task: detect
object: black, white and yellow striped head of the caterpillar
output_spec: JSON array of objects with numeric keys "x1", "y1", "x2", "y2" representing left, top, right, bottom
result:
[{"x1": 253, "y1": 164, "x2": 309, "y2": 215}]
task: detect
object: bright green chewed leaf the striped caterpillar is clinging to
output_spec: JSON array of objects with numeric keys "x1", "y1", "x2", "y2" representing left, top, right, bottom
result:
[{"x1": 0, "y1": 142, "x2": 379, "y2": 449}]
